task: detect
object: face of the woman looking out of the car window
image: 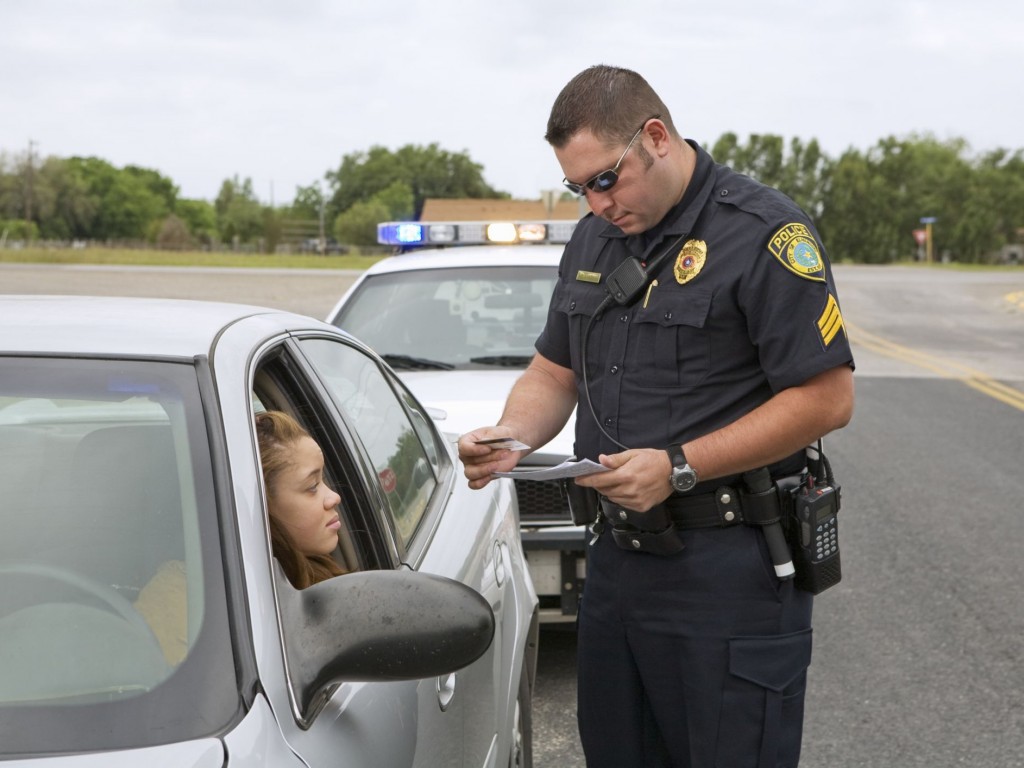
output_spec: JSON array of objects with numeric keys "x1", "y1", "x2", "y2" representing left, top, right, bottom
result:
[{"x1": 269, "y1": 437, "x2": 341, "y2": 556}]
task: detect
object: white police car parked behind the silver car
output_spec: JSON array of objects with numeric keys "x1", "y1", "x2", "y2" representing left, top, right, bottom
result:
[{"x1": 328, "y1": 237, "x2": 587, "y2": 623}]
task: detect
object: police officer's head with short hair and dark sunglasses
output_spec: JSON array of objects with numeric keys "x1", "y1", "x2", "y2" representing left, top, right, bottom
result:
[{"x1": 545, "y1": 65, "x2": 692, "y2": 234}]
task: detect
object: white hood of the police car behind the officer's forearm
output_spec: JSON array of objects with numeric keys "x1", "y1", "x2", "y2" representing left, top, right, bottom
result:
[{"x1": 398, "y1": 369, "x2": 574, "y2": 464}]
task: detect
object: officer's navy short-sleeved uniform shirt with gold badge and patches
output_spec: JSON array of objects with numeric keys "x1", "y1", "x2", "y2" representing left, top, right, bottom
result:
[{"x1": 537, "y1": 141, "x2": 853, "y2": 485}]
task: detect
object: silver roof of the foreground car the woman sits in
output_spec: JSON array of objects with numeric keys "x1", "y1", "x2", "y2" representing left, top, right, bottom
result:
[{"x1": 0, "y1": 296, "x2": 338, "y2": 357}]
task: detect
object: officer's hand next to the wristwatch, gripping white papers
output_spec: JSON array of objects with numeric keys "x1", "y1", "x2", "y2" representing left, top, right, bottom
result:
[{"x1": 577, "y1": 449, "x2": 672, "y2": 512}]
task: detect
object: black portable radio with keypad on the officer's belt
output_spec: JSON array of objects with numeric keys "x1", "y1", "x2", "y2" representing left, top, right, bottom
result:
[{"x1": 788, "y1": 441, "x2": 843, "y2": 595}]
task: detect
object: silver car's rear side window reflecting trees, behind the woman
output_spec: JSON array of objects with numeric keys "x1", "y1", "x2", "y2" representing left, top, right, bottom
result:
[{"x1": 301, "y1": 339, "x2": 439, "y2": 549}]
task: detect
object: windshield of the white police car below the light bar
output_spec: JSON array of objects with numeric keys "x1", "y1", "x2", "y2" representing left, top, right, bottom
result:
[{"x1": 334, "y1": 266, "x2": 558, "y2": 371}]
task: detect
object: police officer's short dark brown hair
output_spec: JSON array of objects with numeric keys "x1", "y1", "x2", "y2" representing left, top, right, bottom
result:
[{"x1": 544, "y1": 65, "x2": 678, "y2": 148}]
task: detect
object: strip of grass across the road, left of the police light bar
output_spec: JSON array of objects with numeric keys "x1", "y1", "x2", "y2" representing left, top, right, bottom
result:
[{"x1": 0, "y1": 247, "x2": 386, "y2": 270}]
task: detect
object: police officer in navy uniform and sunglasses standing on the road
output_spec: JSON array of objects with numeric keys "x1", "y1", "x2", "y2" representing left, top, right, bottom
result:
[{"x1": 459, "y1": 66, "x2": 853, "y2": 768}]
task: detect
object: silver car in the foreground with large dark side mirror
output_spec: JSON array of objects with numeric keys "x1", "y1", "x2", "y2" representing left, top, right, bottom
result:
[{"x1": 0, "y1": 296, "x2": 538, "y2": 768}]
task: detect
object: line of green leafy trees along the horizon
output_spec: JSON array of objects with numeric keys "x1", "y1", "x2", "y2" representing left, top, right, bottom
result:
[{"x1": 0, "y1": 133, "x2": 1024, "y2": 263}]
